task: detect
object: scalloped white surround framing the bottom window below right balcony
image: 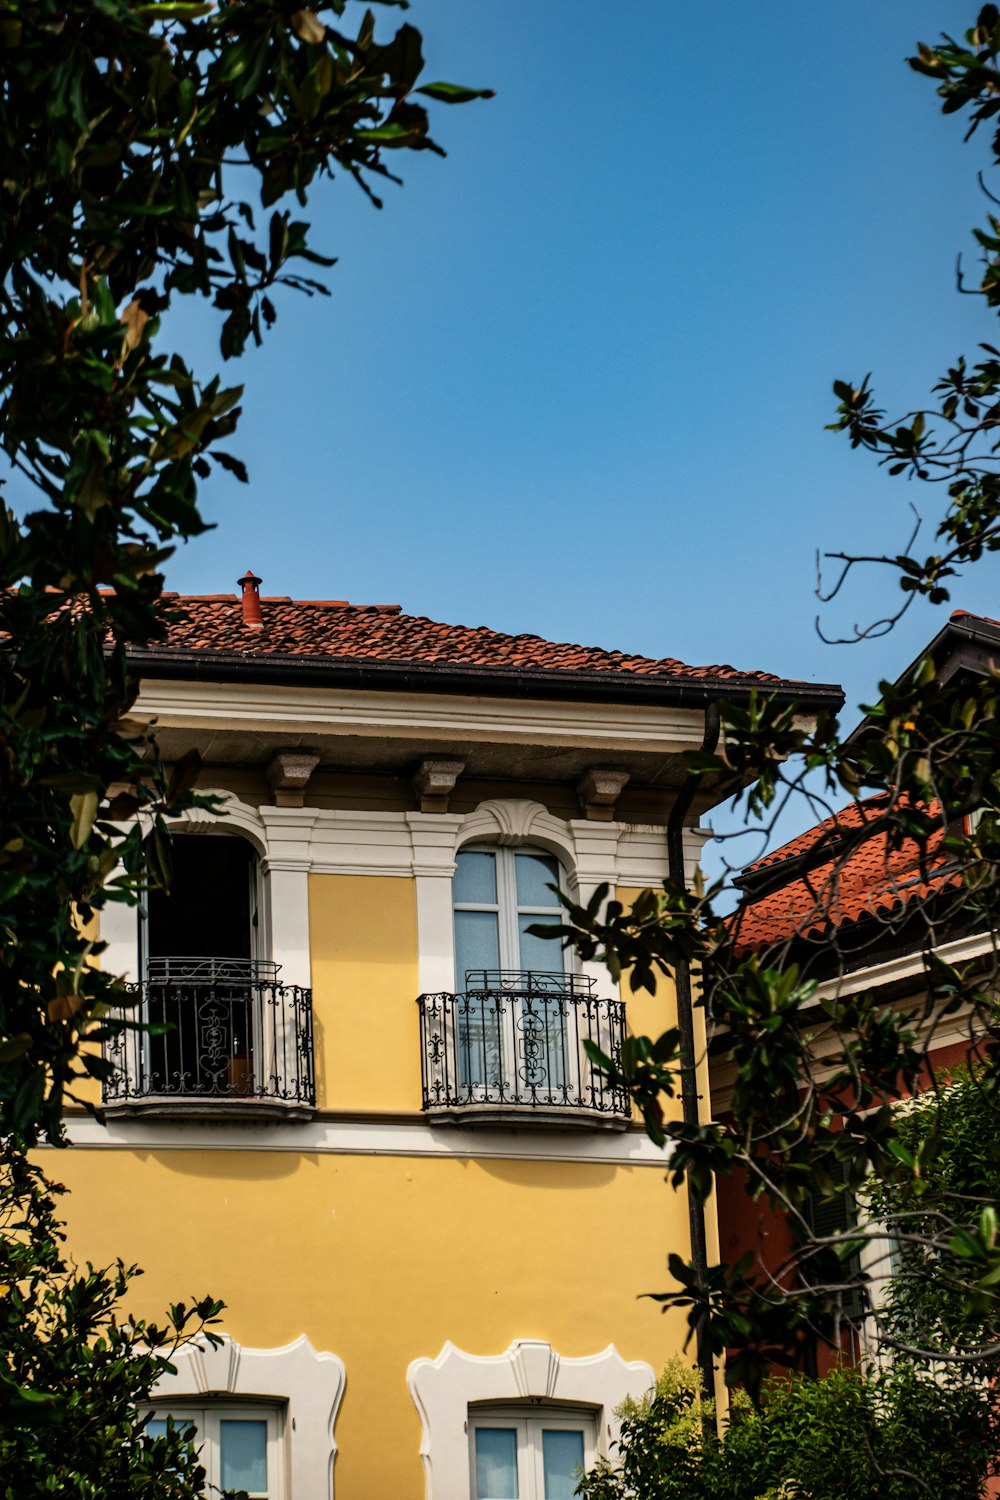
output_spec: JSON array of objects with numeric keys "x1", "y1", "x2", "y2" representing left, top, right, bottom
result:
[{"x1": 406, "y1": 1340, "x2": 654, "y2": 1500}]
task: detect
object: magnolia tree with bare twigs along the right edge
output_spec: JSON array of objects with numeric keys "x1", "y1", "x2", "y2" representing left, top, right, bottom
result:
[{"x1": 539, "y1": 5, "x2": 1000, "y2": 1410}]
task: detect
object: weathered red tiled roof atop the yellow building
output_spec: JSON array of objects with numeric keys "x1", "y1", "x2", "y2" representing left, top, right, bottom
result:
[{"x1": 151, "y1": 594, "x2": 811, "y2": 695}]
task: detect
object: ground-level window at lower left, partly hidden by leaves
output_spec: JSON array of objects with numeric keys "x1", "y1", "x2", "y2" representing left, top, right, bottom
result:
[{"x1": 145, "y1": 1406, "x2": 285, "y2": 1500}]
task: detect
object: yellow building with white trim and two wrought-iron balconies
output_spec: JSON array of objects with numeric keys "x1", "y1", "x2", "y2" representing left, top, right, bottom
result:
[{"x1": 50, "y1": 575, "x2": 839, "y2": 1500}]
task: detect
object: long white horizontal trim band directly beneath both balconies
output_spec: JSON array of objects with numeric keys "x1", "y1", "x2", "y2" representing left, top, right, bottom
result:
[{"x1": 56, "y1": 1115, "x2": 670, "y2": 1172}]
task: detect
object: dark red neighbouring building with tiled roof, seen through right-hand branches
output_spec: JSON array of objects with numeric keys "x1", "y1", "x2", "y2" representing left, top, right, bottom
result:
[{"x1": 711, "y1": 611, "x2": 1000, "y2": 1368}]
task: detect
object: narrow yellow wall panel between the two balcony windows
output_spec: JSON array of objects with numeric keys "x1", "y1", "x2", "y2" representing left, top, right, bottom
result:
[{"x1": 309, "y1": 875, "x2": 420, "y2": 1112}]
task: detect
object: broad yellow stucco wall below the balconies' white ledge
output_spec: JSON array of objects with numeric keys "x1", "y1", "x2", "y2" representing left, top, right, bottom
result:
[{"x1": 52, "y1": 1148, "x2": 687, "y2": 1500}]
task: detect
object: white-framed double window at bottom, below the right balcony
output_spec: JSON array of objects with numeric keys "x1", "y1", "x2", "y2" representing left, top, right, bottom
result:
[{"x1": 469, "y1": 1407, "x2": 595, "y2": 1500}]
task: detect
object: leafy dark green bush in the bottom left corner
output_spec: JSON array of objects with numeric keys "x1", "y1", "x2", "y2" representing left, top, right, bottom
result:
[{"x1": 0, "y1": 1137, "x2": 222, "y2": 1500}]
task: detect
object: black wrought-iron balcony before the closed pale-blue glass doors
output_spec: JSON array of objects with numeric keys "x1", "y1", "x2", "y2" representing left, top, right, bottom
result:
[{"x1": 417, "y1": 969, "x2": 630, "y2": 1130}]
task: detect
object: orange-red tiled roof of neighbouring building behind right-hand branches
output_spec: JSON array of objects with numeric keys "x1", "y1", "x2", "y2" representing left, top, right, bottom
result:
[{"x1": 732, "y1": 792, "x2": 958, "y2": 951}]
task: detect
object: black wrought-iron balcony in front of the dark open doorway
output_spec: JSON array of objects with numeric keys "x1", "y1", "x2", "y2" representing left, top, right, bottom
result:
[{"x1": 103, "y1": 957, "x2": 316, "y2": 1119}]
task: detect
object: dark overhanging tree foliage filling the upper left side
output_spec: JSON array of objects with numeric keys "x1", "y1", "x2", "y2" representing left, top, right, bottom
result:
[{"x1": 0, "y1": 0, "x2": 483, "y2": 1140}]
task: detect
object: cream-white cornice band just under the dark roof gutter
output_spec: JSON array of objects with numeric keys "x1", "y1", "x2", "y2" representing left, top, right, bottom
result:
[{"x1": 129, "y1": 678, "x2": 705, "y2": 756}]
